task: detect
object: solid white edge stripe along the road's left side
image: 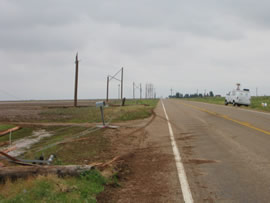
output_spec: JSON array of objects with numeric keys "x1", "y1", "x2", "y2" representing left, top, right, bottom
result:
[{"x1": 161, "y1": 100, "x2": 193, "y2": 203}]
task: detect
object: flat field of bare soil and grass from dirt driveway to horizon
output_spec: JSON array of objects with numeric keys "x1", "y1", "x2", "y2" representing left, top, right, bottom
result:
[{"x1": 0, "y1": 100, "x2": 157, "y2": 123}]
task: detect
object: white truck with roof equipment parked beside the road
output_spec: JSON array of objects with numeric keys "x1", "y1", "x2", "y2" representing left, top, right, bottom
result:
[{"x1": 225, "y1": 84, "x2": 250, "y2": 106}]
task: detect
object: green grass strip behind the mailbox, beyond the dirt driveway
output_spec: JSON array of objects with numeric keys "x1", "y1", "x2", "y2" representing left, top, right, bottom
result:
[{"x1": 40, "y1": 99, "x2": 159, "y2": 123}]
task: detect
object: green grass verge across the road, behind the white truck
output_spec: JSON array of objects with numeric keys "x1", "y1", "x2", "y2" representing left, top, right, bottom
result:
[{"x1": 180, "y1": 96, "x2": 270, "y2": 112}]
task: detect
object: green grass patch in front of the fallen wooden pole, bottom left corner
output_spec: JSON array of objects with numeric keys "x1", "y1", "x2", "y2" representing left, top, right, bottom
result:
[{"x1": 0, "y1": 170, "x2": 112, "y2": 203}]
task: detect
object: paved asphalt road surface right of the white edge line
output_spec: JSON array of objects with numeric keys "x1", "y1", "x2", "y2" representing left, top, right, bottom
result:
[{"x1": 163, "y1": 100, "x2": 270, "y2": 202}]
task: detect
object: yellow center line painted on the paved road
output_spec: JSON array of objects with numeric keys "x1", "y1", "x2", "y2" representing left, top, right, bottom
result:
[{"x1": 183, "y1": 103, "x2": 270, "y2": 135}]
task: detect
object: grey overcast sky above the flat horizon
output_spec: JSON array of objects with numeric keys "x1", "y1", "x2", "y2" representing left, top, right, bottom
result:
[{"x1": 0, "y1": 0, "x2": 270, "y2": 100}]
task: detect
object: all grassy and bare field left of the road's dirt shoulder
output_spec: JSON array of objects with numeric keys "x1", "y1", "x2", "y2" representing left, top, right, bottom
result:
[{"x1": 0, "y1": 100, "x2": 158, "y2": 202}]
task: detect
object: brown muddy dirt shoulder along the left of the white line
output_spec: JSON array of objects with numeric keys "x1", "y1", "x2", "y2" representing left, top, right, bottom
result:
[{"x1": 97, "y1": 107, "x2": 182, "y2": 203}]
